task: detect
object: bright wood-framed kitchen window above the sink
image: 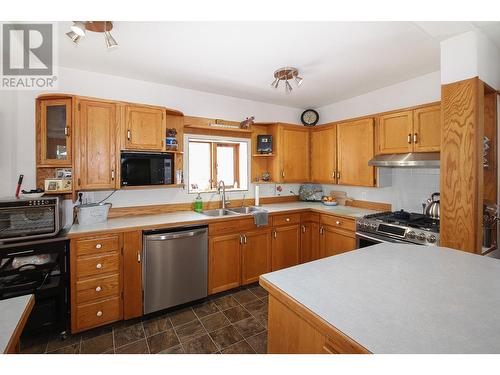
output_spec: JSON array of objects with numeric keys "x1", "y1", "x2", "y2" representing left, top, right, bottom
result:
[{"x1": 188, "y1": 138, "x2": 248, "y2": 193}]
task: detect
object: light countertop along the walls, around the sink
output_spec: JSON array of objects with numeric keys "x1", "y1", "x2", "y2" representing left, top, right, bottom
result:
[{"x1": 68, "y1": 202, "x2": 376, "y2": 237}]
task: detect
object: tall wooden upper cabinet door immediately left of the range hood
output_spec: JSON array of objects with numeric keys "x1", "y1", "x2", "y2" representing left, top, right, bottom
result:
[{"x1": 337, "y1": 118, "x2": 376, "y2": 186}]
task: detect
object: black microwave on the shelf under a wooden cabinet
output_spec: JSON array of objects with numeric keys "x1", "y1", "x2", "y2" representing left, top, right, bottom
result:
[{"x1": 121, "y1": 152, "x2": 174, "y2": 186}]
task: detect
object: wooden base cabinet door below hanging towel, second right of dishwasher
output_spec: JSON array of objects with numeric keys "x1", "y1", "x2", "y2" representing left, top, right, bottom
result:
[{"x1": 241, "y1": 229, "x2": 271, "y2": 285}]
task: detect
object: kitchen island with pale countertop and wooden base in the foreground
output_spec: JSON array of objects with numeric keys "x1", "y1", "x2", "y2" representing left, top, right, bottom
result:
[{"x1": 260, "y1": 244, "x2": 500, "y2": 353}]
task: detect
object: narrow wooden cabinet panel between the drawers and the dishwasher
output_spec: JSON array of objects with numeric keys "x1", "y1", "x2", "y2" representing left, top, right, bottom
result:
[{"x1": 123, "y1": 231, "x2": 142, "y2": 319}]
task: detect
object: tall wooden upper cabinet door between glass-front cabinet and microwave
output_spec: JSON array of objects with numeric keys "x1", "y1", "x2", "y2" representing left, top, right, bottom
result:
[{"x1": 75, "y1": 100, "x2": 118, "y2": 190}]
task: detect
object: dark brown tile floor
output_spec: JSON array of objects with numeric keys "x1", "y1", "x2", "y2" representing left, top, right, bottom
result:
[{"x1": 21, "y1": 284, "x2": 268, "y2": 354}]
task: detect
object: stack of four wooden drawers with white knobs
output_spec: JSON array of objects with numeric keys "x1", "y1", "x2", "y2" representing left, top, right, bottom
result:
[{"x1": 71, "y1": 234, "x2": 122, "y2": 333}]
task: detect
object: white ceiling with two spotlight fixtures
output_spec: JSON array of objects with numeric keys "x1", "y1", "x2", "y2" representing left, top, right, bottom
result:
[{"x1": 58, "y1": 22, "x2": 500, "y2": 108}]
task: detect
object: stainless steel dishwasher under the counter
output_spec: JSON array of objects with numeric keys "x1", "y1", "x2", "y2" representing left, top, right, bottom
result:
[{"x1": 142, "y1": 226, "x2": 208, "y2": 314}]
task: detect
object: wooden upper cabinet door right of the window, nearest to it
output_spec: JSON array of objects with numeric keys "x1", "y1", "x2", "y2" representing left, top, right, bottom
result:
[{"x1": 278, "y1": 126, "x2": 310, "y2": 182}]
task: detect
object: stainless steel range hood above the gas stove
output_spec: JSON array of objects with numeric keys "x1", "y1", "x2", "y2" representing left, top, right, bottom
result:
[{"x1": 368, "y1": 152, "x2": 440, "y2": 168}]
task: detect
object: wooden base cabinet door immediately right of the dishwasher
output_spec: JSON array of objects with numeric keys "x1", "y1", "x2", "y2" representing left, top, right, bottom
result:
[{"x1": 208, "y1": 234, "x2": 241, "y2": 294}]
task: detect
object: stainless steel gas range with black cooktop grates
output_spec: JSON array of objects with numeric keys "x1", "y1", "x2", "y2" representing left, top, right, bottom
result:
[{"x1": 356, "y1": 210, "x2": 439, "y2": 246}]
